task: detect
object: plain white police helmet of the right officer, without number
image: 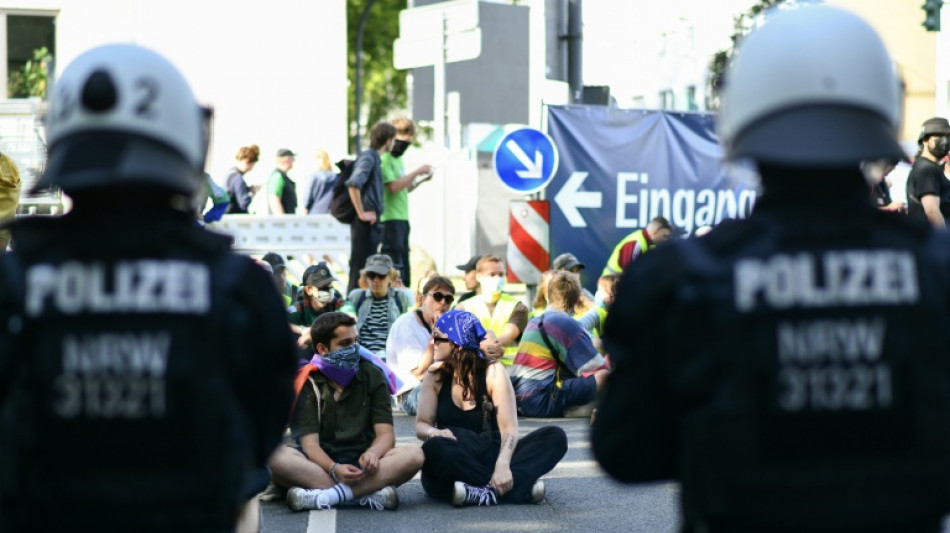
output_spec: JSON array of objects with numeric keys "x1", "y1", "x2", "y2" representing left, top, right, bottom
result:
[{"x1": 718, "y1": 4, "x2": 905, "y2": 167}]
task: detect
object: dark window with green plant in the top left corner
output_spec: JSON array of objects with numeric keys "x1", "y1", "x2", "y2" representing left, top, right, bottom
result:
[{"x1": 0, "y1": 10, "x2": 56, "y2": 99}]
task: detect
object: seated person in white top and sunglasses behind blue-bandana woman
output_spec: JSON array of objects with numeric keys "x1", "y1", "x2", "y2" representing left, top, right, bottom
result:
[{"x1": 386, "y1": 276, "x2": 455, "y2": 416}]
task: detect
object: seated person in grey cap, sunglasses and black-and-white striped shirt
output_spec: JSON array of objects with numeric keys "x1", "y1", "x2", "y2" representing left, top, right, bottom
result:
[{"x1": 347, "y1": 254, "x2": 413, "y2": 359}]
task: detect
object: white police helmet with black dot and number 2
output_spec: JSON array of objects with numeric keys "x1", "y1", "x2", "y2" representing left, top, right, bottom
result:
[{"x1": 36, "y1": 44, "x2": 210, "y2": 195}]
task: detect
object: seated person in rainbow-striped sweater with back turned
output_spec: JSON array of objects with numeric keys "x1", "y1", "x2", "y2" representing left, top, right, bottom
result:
[{"x1": 510, "y1": 272, "x2": 608, "y2": 417}]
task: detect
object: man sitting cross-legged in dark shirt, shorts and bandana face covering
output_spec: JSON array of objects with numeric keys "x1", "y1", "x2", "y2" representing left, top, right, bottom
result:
[{"x1": 269, "y1": 312, "x2": 424, "y2": 511}]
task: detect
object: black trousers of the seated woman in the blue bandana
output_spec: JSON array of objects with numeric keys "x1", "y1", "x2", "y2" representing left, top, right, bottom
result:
[{"x1": 422, "y1": 426, "x2": 567, "y2": 503}]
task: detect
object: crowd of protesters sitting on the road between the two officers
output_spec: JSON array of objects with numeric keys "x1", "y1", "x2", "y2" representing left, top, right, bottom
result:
[{"x1": 249, "y1": 243, "x2": 617, "y2": 510}]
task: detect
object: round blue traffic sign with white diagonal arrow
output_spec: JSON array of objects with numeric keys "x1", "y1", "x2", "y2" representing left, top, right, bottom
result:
[{"x1": 492, "y1": 128, "x2": 558, "y2": 194}]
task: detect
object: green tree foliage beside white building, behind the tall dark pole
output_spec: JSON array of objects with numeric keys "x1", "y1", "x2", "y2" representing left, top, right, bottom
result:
[{"x1": 346, "y1": 0, "x2": 407, "y2": 152}]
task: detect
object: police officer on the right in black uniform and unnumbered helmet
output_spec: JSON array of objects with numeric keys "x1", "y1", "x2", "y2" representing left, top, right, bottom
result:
[{"x1": 592, "y1": 5, "x2": 950, "y2": 533}]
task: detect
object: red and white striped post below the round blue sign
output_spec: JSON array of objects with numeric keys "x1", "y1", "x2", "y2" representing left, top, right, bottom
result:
[{"x1": 507, "y1": 200, "x2": 551, "y2": 285}]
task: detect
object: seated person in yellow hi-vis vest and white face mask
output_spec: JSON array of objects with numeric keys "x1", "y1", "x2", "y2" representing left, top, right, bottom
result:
[{"x1": 457, "y1": 255, "x2": 528, "y2": 366}]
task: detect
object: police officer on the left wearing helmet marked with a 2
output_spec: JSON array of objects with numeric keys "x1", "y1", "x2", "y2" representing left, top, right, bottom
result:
[{"x1": 0, "y1": 45, "x2": 296, "y2": 532}]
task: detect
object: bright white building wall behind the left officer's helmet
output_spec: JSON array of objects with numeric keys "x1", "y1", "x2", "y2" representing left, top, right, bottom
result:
[{"x1": 0, "y1": 0, "x2": 347, "y2": 191}]
